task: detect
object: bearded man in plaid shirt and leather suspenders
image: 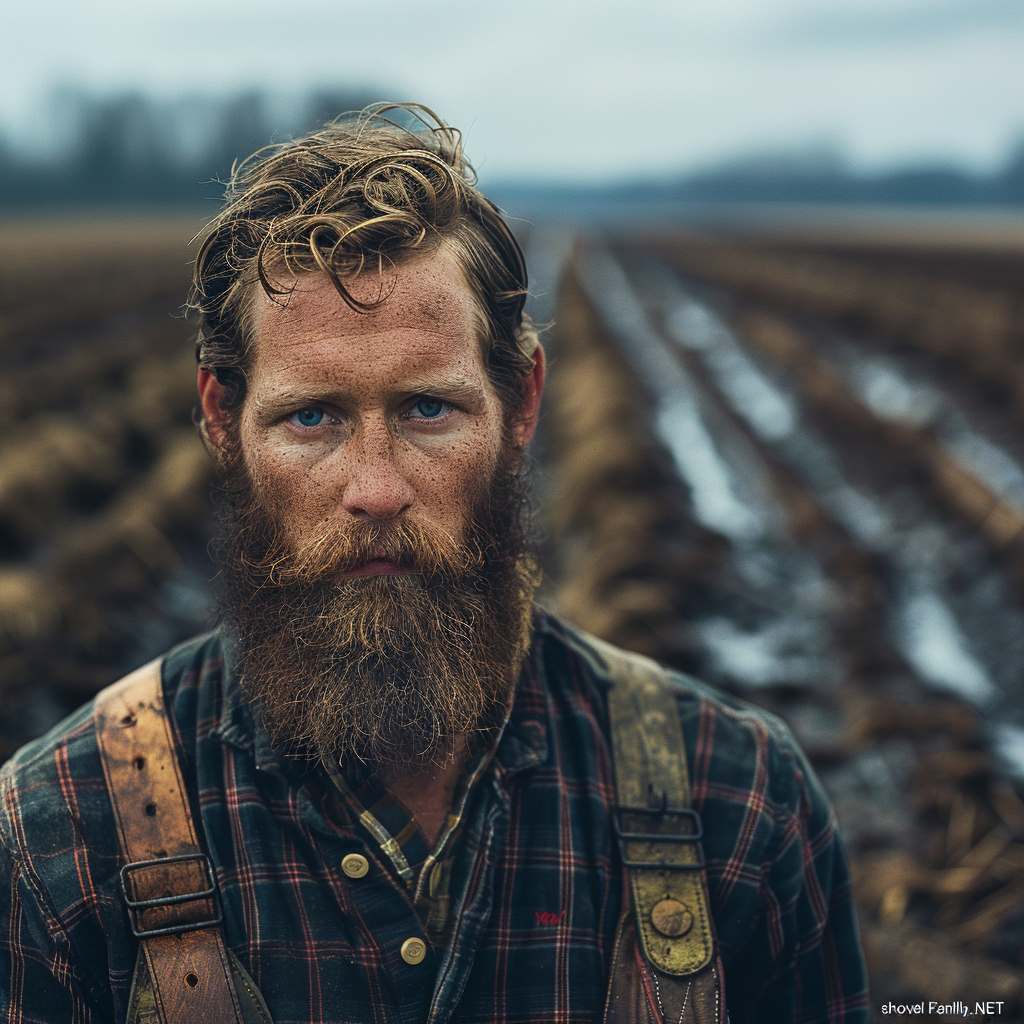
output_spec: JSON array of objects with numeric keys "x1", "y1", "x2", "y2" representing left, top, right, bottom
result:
[{"x1": 0, "y1": 109, "x2": 868, "y2": 1024}]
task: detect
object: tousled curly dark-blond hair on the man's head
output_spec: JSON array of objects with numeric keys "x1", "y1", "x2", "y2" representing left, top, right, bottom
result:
[{"x1": 188, "y1": 103, "x2": 538, "y2": 427}]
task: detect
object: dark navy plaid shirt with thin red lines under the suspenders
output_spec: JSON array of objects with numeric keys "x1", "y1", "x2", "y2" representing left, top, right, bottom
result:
[{"x1": 0, "y1": 615, "x2": 870, "y2": 1024}]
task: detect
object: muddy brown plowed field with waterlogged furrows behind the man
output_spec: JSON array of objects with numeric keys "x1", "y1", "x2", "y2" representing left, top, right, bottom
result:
[{"x1": 0, "y1": 214, "x2": 1024, "y2": 1019}]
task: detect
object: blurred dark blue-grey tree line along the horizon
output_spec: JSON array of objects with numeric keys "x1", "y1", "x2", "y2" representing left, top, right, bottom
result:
[{"x1": 0, "y1": 89, "x2": 1024, "y2": 210}]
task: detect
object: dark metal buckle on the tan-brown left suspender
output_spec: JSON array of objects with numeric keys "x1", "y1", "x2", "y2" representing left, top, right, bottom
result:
[{"x1": 121, "y1": 853, "x2": 224, "y2": 939}]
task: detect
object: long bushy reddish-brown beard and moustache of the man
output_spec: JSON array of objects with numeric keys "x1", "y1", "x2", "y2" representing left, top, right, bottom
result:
[{"x1": 212, "y1": 440, "x2": 538, "y2": 770}]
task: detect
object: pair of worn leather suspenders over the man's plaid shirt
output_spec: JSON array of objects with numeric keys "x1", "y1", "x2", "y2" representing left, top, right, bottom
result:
[{"x1": 94, "y1": 636, "x2": 727, "y2": 1024}]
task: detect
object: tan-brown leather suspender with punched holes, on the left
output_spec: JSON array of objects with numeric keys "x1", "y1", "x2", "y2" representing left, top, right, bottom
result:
[{"x1": 93, "y1": 659, "x2": 243, "y2": 1024}]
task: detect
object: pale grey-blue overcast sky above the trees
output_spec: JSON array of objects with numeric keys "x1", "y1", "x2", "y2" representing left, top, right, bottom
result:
[{"x1": 0, "y1": 0, "x2": 1024, "y2": 182}]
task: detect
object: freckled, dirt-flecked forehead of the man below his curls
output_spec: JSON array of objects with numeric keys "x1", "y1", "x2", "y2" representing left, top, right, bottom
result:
[{"x1": 251, "y1": 248, "x2": 485, "y2": 369}]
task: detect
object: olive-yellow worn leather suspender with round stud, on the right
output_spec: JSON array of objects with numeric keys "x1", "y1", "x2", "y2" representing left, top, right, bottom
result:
[{"x1": 586, "y1": 636, "x2": 726, "y2": 1024}]
